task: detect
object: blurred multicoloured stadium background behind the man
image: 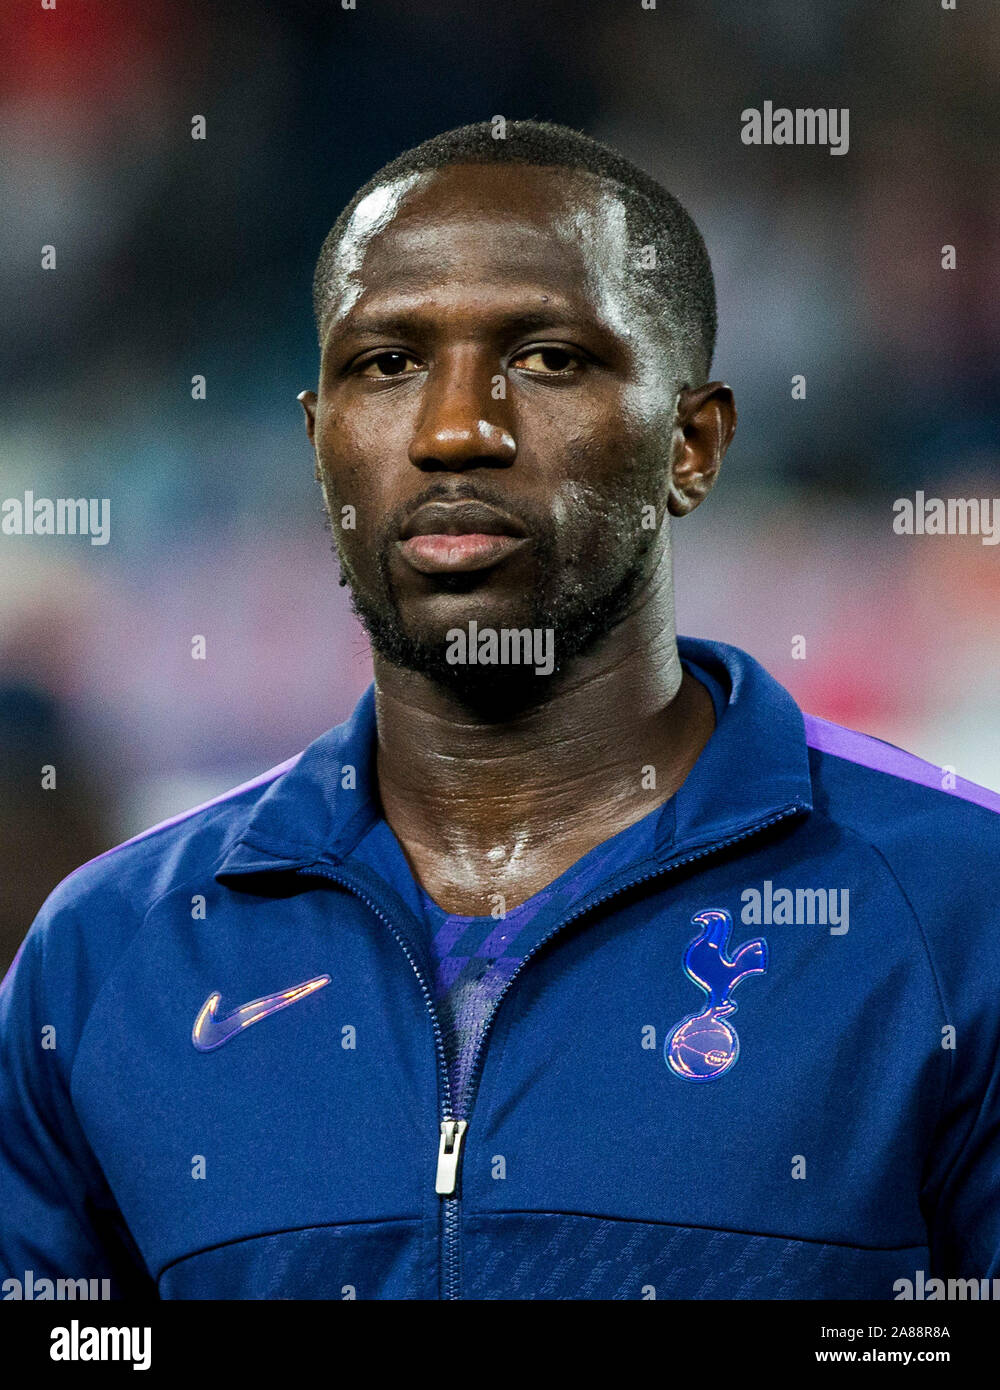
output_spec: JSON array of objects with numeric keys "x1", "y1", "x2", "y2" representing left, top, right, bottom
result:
[{"x1": 0, "y1": 0, "x2": 1000, "y2": 969}]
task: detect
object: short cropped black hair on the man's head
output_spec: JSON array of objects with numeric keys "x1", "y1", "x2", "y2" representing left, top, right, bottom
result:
[{"x1": 313, "y1": 118, "x2": 716, "y2": 385}]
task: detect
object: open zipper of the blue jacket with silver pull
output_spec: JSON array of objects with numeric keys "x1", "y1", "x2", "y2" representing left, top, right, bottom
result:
[{"x1": 302, "y1": 802, "x2": 808, "y2": 1300}]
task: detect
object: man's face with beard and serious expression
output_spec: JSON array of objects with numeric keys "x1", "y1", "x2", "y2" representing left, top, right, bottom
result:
[{"x1": 306, "y1": 164, "x2": 689, "y2": 695}]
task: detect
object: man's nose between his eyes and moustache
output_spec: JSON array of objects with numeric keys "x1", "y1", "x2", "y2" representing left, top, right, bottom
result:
[{"x1": 409, "y1": 353, "x2": 517, "y2": 473}]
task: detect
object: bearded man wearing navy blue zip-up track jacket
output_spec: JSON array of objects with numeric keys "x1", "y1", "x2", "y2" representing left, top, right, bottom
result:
[{"x1": 0, "y1": 122, "x2": 1000, "y2": 1300}]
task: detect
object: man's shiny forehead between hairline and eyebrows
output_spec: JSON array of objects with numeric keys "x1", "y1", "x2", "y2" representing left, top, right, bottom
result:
[{"x1": 324, "y1": 164, "x2": 630, "y2": 325}]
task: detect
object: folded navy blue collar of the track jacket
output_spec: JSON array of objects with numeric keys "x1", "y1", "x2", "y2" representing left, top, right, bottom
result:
[{"x1": 216, "y1": 637, "x2": 812, "y2": 880}]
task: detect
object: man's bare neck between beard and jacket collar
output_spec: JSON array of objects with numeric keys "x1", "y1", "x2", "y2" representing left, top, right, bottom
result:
[{"x1": 376, "y1": 556, "x2": 713, "y2": 912}]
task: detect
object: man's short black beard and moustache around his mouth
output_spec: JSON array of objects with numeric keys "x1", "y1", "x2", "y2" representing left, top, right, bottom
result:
[{"x1": 335, "y1": 478, "x2": 658, "y2": 719}]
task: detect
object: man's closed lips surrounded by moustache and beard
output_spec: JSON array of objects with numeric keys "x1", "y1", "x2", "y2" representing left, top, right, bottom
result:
[{"x1": 399, "y1": 502, "x2": 527, "y2": 574}]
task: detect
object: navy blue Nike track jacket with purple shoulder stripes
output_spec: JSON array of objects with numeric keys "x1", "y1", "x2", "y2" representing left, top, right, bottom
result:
[{"x1": 0, "y1": 638, "x2": 1000, "y2": 1300}]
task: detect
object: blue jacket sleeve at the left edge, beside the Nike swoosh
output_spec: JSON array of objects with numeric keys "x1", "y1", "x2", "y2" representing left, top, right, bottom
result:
[{"x1": 0, "y1": 890, "x2": 156, "y2": 1300}]
